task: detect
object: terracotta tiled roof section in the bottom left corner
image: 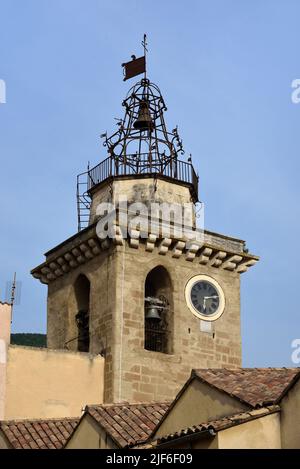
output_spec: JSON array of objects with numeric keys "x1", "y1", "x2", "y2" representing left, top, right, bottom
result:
[{"x1": 0, "y1": 418, "x2": 78, "y2": 449}]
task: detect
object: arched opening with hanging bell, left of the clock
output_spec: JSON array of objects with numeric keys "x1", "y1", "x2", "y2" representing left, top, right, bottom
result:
[{"x1": 144, "y1": 266, "x2": 173, "y2": 353}]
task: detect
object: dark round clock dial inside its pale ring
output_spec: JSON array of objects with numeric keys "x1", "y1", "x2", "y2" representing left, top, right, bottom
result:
[{"x1": 191, "y1": 280, "x2": 220, "y2": 316}]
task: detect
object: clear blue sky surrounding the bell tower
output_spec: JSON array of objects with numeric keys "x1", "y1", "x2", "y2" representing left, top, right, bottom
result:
[{"x1": 0, "y1": 0, "x2": 300, "y2": 366}]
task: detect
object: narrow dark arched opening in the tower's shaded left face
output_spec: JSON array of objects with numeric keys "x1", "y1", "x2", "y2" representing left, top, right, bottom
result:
[{"x1": 74, "y1": 274, "x2": 90, "y2": 352}]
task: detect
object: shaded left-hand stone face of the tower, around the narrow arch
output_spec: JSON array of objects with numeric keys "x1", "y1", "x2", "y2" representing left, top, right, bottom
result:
[{"x1": 47, "y1": 250, "x2": 116, "y2": 395}]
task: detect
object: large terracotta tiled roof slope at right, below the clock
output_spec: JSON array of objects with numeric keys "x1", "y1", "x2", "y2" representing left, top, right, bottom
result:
[{"x1": 192, "y1": 368, "x2": 300, "y2": 407}]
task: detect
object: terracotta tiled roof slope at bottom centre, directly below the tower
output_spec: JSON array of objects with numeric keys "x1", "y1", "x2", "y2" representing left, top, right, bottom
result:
[{"x1": 85, "y1": 402, "x2": 170, "y2": 448}]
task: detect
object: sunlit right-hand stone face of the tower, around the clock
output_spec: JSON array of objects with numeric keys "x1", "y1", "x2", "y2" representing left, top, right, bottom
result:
[{"x1": 110, "y1": 241, "x2": 241, "y2": 402}]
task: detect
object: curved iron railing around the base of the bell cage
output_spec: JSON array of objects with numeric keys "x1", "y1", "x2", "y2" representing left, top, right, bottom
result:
[{"x1": 87, "y1": 153, "x2": 198, "y2": 200}]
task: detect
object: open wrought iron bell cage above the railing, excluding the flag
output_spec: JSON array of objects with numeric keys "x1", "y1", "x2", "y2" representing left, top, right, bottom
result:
[{"x1": 104, "y1": 78, "x2": 184, "y2": 179}]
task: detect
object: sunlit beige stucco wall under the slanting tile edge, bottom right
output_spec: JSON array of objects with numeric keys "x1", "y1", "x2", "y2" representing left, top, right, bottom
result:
[{"x1": 218, "y1": 413, "x2": 281, "y2": 449}]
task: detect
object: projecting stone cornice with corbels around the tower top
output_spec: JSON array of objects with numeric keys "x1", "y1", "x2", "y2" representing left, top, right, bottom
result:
[{"x1": 31, "y1": 225, "x2": 259, "y2": 284}]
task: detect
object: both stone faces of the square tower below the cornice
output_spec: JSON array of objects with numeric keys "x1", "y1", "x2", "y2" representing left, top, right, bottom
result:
[{"x1": 48, "y1": 236, "x2": 241, "y2": 402}]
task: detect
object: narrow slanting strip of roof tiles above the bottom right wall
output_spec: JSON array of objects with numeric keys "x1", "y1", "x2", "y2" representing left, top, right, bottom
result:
[{"x1": 156, "y1": 405, "x2": 280, "y2": 446}]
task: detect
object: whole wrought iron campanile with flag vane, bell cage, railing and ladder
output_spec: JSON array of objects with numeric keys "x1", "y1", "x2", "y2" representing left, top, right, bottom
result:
[{"x1": 77, "y1": 45, "x2": 198, "y2": 231}]
